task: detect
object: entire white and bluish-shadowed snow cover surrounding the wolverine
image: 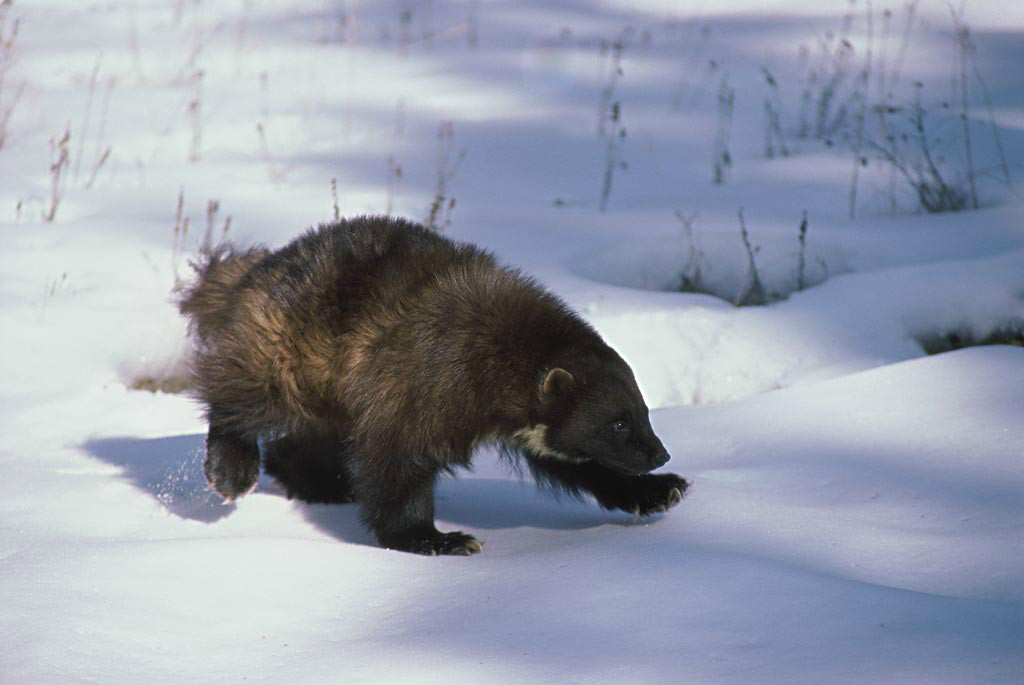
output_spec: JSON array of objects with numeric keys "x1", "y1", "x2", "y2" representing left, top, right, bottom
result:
[{"x1": 0, "y1": 0, "x2": 1024, "y2": 684}]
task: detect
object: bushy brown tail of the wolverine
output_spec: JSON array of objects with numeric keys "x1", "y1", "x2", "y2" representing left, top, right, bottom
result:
[{"x1": 178, "y1": 245, "x2": 268, "y2": 341}]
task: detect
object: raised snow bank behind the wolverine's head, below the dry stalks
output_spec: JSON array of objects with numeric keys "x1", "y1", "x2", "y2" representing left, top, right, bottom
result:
[{"x1": 584, "y1": 242, "x2": 1024, "y2": 406}]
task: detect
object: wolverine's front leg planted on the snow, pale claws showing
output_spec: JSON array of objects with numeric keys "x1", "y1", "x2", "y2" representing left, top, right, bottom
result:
[{"x1": 355, "y1": 460, "x2": 480, "y2": 555}]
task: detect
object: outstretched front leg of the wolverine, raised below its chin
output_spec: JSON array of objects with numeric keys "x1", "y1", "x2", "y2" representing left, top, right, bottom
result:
[{"x1": 526, "y1": 453, "x2": 690, "y2": 516}]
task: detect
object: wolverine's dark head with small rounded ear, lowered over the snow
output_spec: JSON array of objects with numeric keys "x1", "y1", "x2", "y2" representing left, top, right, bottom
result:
[{"x1": 520, "y1": 349, "x2": 669, "y2": 474}]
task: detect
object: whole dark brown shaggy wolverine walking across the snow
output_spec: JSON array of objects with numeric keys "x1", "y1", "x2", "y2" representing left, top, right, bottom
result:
[{"x1": 179, "y1": 216, "x2": 689, "y2": 555}]
